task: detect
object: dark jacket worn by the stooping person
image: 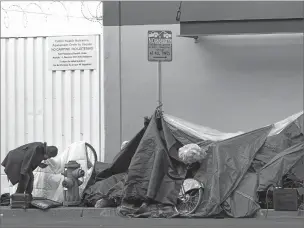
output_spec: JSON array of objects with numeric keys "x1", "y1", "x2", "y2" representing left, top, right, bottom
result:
[{"x1": 1, "y1": 142, "x2": 45, "y2": 185}]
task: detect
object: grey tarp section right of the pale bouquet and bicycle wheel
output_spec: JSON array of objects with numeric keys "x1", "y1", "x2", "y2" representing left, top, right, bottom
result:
[{"x1": 194, "y1": 126, "x2": 271, "y2": 217}]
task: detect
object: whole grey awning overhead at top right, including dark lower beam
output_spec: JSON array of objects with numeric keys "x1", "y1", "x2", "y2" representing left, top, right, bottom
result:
[{"x1": 179, "y1": 1, "x2": 304, "y2": 38}]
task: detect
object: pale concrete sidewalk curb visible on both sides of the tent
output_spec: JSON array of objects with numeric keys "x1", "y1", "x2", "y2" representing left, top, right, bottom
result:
[{"x1": 0, "y1": 207, "x2": 304, "y2": 219}]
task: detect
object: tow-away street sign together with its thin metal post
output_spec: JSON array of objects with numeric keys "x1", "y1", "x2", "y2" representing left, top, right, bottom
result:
[{"x1": 148, "y1": 30, "x2": 172, "y2": 108}]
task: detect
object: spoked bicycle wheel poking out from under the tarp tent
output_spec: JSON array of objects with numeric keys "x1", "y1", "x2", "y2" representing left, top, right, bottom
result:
[{"x1": 176, "y1": 179, "x2": 203, "y2": 215}]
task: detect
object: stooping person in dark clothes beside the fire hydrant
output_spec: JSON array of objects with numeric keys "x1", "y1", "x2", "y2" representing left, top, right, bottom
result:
[{"x1": 1, "y1": 142, "x2": 58, "y2": 195}]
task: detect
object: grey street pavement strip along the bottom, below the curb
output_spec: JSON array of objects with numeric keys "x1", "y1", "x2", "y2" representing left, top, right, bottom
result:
[{"x1": 0, "y1": 216, "x2": 304, "y2": 228}]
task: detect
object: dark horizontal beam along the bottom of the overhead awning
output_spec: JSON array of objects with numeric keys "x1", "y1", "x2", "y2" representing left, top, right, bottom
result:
[{"x1": 180, "y1": 18, "x2": 304, "y2": 38}]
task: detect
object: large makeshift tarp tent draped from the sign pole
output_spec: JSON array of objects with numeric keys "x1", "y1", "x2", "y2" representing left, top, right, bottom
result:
[{"x1": 82, "y1": 110, "x2": 304, "y2": 218}]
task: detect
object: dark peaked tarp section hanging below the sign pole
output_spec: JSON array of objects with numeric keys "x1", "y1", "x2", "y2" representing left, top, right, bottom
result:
[{"x1": 86, "y1": 112, "x2": 186, "y2": 212}]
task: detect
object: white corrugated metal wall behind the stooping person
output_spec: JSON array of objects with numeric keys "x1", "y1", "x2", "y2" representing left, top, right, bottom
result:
[{"x1": 1, "y1": 35, "x2": 104, "y2": 164}]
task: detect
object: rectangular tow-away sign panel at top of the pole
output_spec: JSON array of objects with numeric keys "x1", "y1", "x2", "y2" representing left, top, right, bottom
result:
[{"x1": 148, "y1": 30, "x2": 172, "y2": 62}]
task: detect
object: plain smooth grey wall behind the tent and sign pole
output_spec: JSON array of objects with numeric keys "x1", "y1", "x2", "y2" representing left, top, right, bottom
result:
[{"x1": 104, "y1": 25, "x2": 303, "y2": 161}]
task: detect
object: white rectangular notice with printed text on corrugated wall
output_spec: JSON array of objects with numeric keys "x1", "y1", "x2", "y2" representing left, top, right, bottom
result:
[{"x1": 48, "y1": 36, "x2": 97, "y2": 71}]
